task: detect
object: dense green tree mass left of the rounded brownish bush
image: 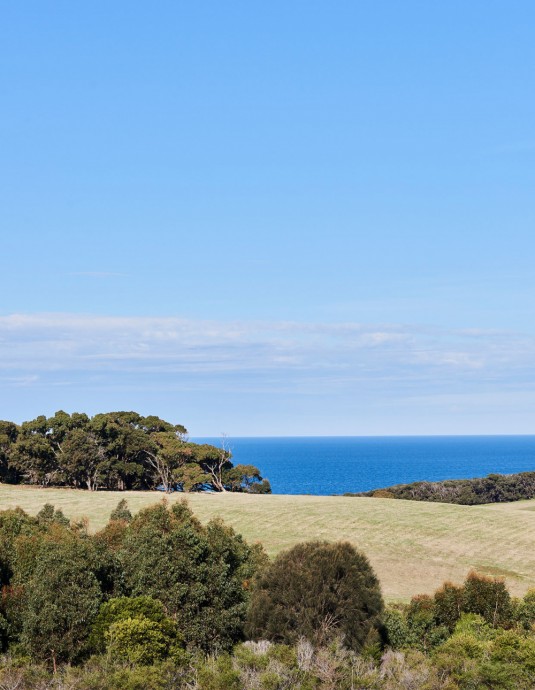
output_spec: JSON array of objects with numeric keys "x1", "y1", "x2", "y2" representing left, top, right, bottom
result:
[{"x1": 0, "y1": 503, "x2": 265, "y2": 666}]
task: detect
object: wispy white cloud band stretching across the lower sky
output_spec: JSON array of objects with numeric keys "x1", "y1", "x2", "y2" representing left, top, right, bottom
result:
[{"x1": 0, "y1": 313, "x2": 535, "y2": 398}]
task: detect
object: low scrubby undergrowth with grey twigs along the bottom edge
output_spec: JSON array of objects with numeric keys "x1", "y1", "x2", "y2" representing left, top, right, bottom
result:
[{"x1": 0, "y1": 620, "x2": 535, "y2": 690}]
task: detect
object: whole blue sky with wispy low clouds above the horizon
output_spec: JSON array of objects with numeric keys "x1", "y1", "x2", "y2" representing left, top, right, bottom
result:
[{"x1": 0, "y1": 0, "x2": 535, "y2": 436}]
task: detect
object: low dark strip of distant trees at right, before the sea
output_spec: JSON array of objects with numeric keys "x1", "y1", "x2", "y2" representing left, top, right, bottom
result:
[{"x1": 344, "y1": 472, "x2": 535, "y2": 505}]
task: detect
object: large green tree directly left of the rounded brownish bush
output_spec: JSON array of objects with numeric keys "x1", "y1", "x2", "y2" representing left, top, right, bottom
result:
[{"x1": 118, "y1": 503, "x2": 258, "y2": 651}]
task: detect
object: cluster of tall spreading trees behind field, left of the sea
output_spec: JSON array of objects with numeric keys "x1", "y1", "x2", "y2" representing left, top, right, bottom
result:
[{"x1": 0, "y1": 411, "x2": 271, "y2": 493}]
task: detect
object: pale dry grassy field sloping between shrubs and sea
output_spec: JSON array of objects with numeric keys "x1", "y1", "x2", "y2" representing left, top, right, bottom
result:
[{"x1": 0, "y1": 484, "x2": 535, "y2": 599}]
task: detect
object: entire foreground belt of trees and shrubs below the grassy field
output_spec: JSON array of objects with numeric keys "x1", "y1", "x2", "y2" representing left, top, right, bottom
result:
[{"x1": 0, "y1": 501, "x2": 535, "y2": 690}]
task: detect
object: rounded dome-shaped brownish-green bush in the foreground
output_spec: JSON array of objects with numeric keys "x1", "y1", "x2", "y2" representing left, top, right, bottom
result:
[{"x1": 246, "y1": 541, "x2": 383, "y2": 649}]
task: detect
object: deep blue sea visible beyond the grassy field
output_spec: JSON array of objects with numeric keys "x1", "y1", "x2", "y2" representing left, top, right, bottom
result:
[{"x1": 192, "y1": 436, "x2": 535, "y2": 496}]
